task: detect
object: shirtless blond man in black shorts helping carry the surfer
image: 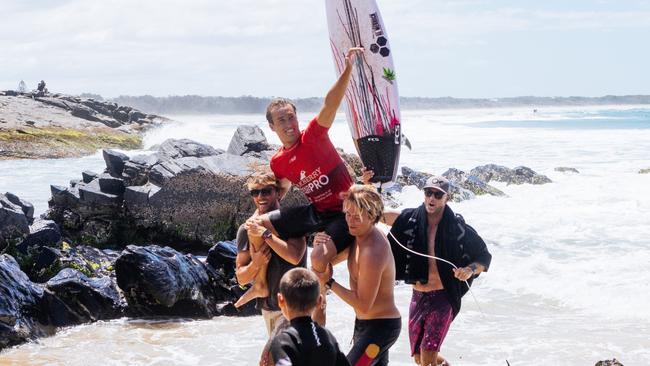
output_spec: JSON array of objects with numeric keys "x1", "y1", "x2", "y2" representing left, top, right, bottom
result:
[{"x1": 314, "y1": 185, "x2": 402, "y2": 365}]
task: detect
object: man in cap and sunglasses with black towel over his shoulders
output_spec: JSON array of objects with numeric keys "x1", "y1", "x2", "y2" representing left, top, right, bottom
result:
[{"x1": 372, "y1": 172, "x2": 492, "y2": 366}]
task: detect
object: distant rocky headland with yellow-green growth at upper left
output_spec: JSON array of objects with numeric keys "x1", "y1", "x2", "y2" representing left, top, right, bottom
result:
[{"x1": 0, "y1": 91, "x2": 167, "y2": 159}]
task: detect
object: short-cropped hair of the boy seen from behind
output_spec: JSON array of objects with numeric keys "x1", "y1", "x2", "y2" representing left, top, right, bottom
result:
[{"x1": 279, "y1": 267, "x2": 320, "y2": 312}]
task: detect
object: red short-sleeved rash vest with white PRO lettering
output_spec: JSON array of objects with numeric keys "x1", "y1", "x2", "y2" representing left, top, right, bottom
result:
[{"x1": 271, "y1": 118, "x2": 352, "y2": 212}]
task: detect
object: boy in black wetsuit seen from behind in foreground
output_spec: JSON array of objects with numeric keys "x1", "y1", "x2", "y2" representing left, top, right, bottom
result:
[{"x1": 271, "y1": 268, "x2": 350, "y2": 366}]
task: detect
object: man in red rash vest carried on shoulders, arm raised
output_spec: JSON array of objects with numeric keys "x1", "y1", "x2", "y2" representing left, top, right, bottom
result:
[{"x1": 254, "y1": 48, "x2": 363, "y2": 325}]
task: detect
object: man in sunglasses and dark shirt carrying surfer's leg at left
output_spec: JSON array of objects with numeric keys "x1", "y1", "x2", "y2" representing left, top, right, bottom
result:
[{"x1": 235, "y1": 171, "x2": 307, "y2": 346}]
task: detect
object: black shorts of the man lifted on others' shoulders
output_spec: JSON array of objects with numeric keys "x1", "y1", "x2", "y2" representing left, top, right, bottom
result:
[{"x1": 269, "y1": 205, "x2": 354, "y2": 253}]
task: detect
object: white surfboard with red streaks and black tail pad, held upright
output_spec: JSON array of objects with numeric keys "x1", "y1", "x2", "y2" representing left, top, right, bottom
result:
[{"x1": 325, "y1": 0, "x2": 402, "y2": 183}]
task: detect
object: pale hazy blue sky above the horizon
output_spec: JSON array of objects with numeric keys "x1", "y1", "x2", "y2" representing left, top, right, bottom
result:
[{"x1": 0, "y1": 0, "x2": 650, "y2": 97}]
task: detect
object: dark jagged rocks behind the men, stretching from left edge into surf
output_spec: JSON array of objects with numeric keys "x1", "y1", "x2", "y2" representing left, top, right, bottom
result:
[{"x1": 0, "y1": 126, "x2": 550, "y2": 349}]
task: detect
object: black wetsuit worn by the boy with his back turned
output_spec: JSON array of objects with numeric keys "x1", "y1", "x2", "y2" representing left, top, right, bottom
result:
[{"x1": 271, "y1": 316, "x2": 350, "y2": 366}]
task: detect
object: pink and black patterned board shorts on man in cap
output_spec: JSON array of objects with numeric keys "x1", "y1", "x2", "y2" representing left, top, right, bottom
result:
[{"x1": 409, "y1": 290, "x2": 454, "y2": 356}]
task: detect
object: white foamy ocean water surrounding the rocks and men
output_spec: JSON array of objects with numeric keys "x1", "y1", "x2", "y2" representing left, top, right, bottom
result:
[{"x1": 0, "y1": 106, "x2": 650, "y2": 366}]
